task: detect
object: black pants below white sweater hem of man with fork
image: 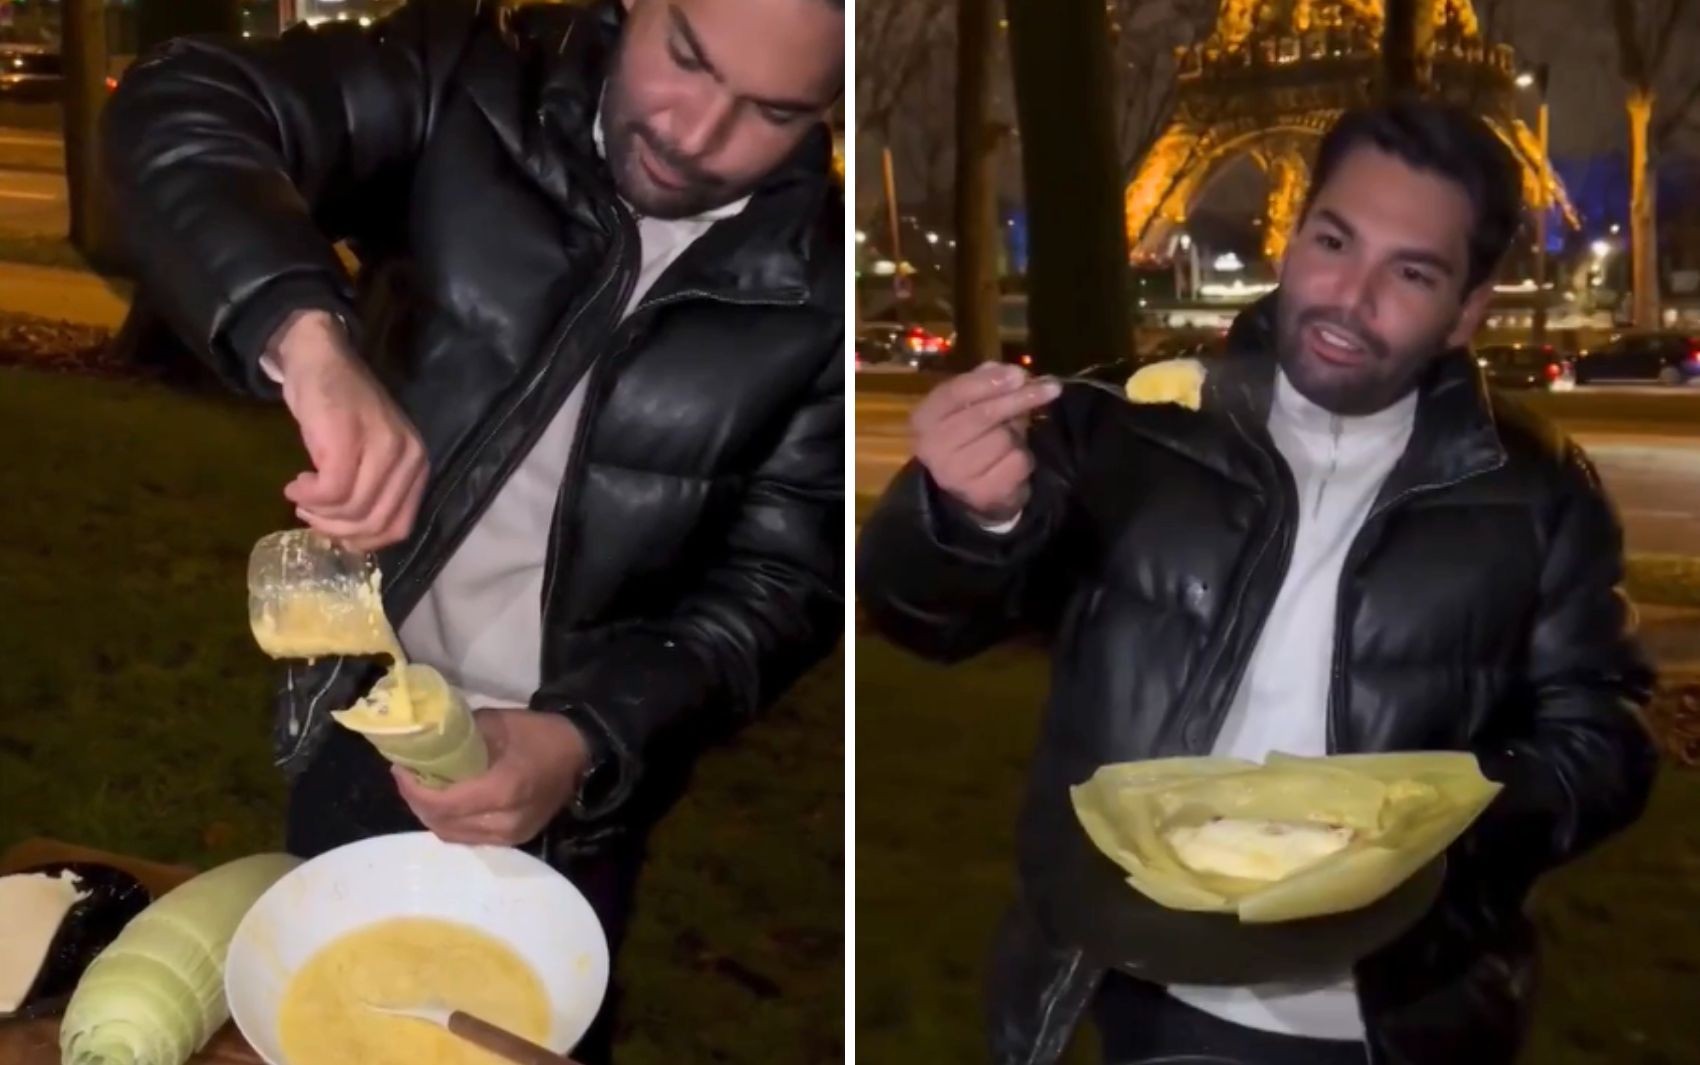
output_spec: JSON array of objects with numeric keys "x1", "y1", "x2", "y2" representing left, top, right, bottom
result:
[{"x1": 1093, "y1": 973, "x2": 1369, "y2": 1065}]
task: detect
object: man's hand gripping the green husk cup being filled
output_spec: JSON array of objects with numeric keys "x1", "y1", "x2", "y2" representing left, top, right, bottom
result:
[{"x1": 394, "y1": 709, "x2": 590, "y2": 847}]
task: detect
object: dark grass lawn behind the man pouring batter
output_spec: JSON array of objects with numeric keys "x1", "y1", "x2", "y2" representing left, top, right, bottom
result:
[{"x1": 0, "y1": 367, "x2": 843, "y2": 1065}]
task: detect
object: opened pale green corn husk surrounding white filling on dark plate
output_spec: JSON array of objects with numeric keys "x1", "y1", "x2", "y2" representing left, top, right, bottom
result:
[{"x1": 1069, "y1": 752, "x2": 1499, "y2": 924}]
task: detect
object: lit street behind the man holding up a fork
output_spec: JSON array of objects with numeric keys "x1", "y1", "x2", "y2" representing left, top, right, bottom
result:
[{"x1": 855, "y1": 381, "x2": 1700, "y2": 555}]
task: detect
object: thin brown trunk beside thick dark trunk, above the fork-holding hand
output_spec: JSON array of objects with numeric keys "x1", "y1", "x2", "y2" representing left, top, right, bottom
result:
[{"x1": 950, "y1": 0, "x2": 1001, "y2": 369}]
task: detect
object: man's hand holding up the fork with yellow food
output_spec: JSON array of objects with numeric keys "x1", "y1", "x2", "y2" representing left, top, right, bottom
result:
[{"x1": 910, "y1": 364, "x2": 1061, "y2": 524}]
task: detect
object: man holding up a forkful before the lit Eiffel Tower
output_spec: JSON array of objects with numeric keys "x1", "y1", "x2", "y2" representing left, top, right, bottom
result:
[{"x1": 859, "y1": 104, "x2": 1656, "y2": 1065}]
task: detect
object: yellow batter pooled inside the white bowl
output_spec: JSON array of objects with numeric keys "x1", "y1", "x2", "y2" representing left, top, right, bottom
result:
[{"x1": 277, "y1": 917, "x2": 549, "y2": 1065}]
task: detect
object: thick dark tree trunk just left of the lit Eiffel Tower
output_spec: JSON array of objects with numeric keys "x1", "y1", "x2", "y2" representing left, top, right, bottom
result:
[{"x1": 1008, "y1": 0, "x2": 1132, "y2": 373}]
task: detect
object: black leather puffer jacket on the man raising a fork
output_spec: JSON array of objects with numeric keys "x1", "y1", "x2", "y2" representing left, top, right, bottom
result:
[{"x1": 859, "y1": 296, "x2": 1656, "y2": 1065}]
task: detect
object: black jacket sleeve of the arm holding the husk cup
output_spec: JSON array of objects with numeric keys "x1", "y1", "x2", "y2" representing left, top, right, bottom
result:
[{"x1": 530, "y1": 343, "x2": 845, "y2": 820}]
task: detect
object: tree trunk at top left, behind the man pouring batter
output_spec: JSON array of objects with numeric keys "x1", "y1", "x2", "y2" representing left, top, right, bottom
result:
[{"x1": 60, "y1": 0, "x2": 122, "y2": 272}]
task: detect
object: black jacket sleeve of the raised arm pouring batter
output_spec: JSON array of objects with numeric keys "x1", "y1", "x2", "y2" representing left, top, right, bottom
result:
[{"x1": 102, "y1": 0, "x2": 478, "y2": 396}]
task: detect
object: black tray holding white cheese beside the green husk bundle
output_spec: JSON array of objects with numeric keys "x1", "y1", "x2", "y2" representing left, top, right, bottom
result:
[{"x1": 0, "y1": 861, "x2": 153, "y2": 1021}]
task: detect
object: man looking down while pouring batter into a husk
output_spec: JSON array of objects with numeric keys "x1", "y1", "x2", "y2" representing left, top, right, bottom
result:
[{"x1": 105, "y1": 0, "x2": 845, "y2": 1062}]
